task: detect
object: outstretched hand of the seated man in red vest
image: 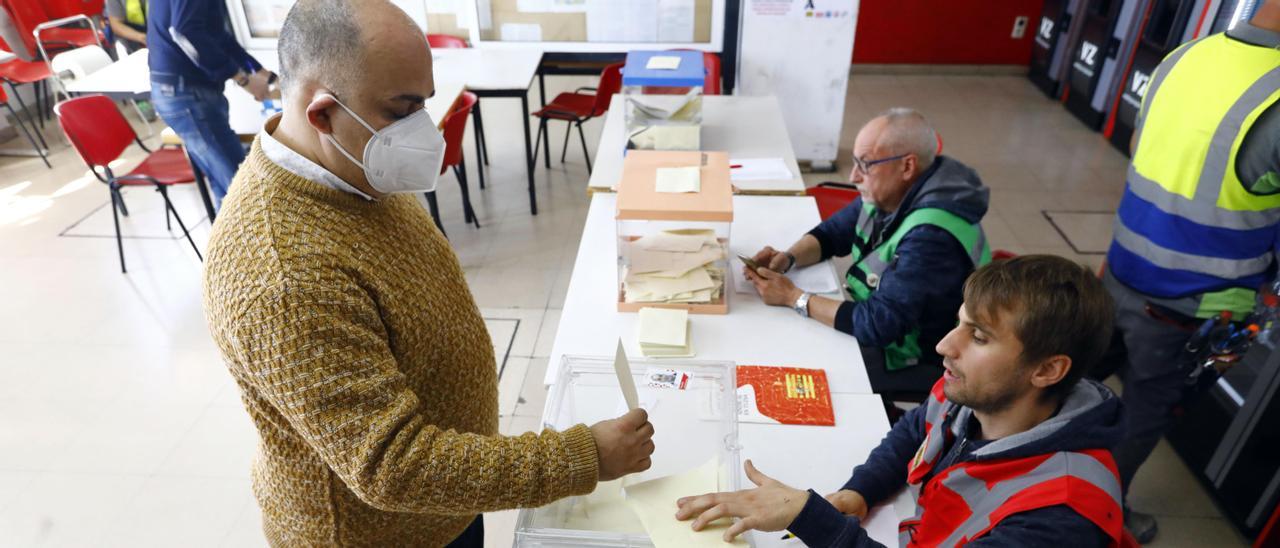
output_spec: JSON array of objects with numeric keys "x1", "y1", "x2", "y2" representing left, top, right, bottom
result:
[{"x1": 676, "y1": 460, "x2": 809, "y2": 542}]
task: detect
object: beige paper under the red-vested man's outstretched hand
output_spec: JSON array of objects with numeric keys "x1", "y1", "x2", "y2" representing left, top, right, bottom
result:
[{"x1": 622, "y1": 457, "x2": 748, "y2": 548}]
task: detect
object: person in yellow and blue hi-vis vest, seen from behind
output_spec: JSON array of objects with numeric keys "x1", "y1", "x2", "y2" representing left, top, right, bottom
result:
[{"x1": 1103, "y1": 0, "x2": 1280, "y2": 542}]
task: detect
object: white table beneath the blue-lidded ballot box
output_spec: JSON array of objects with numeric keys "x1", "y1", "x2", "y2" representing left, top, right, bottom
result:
[{"x1": 588, "y1": 95, "x2": 805, "y2": 196}]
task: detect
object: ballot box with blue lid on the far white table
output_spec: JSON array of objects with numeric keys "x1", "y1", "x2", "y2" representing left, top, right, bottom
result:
[{"x1": 622, "y1": 51, "x2": 707, "y2": 150}]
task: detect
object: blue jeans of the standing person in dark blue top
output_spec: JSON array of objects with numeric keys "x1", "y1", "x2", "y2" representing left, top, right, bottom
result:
[{"x1": 151, "y1": 73, "x2": 244, "y2": 209}]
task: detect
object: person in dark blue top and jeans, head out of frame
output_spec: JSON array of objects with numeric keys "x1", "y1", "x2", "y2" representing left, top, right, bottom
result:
[{"x1": 147, "y1": 0, "x2": 271, "y2": 206}]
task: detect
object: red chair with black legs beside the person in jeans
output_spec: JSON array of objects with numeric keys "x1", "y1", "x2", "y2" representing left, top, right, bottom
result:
[{"x1": 54, "y1": 95, "x2": 205, "y2": 273}]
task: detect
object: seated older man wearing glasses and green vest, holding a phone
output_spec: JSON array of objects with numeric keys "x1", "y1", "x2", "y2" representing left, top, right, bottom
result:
[{"x1": 746, "y1": 109, "x2": 991, "y2": 401}]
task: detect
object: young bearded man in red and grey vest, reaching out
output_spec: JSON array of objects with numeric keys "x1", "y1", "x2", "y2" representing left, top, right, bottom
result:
[{"x1": 676, "y1": 255, "x2": 1135, "y2": 547}]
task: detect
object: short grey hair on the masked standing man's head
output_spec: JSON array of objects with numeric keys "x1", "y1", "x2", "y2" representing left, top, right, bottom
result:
[{"x1": 278, "y1": 0, "x2": 364, "y2": 93}]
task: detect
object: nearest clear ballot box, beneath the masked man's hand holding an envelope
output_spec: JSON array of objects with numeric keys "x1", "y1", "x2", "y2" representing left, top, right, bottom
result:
[{"x1": 515, "y1": 356, "x2": 742, "y2": 547}]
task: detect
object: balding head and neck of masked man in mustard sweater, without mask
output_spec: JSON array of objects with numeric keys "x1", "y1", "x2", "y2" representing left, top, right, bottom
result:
[{"x1": 265, "y1": 0, "x2": 435, "y2": 197}]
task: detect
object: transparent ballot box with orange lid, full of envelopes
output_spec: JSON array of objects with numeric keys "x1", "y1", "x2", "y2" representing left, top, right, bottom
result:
[{"x1": 617, "y1": 150, "x2": 733, "y2": 314}]
